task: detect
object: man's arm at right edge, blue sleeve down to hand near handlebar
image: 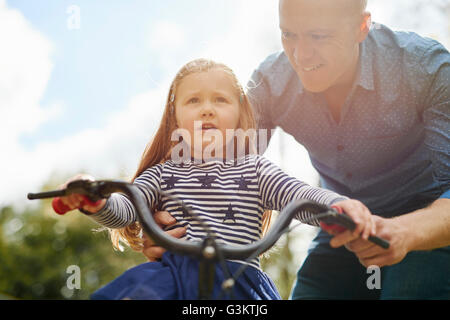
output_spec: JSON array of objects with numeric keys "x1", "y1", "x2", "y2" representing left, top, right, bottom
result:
[{"x1": 330, "y1": 44, "x2": 450, "y2": 266}]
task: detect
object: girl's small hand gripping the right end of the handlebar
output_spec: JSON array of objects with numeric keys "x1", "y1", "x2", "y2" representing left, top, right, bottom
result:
[{"x1": 330, "y1": 199, "x2": 376, "y2": 248}]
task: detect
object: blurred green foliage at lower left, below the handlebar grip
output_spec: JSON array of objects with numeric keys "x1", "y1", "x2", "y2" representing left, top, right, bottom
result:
[{"x1": 0, "y1": 201, "x2": 145, "y2": 299}]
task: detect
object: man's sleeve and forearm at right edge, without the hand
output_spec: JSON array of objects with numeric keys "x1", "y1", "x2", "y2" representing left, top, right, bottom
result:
[{"x1": 398, "y1": 43, "x2": 450, "y2": 251}]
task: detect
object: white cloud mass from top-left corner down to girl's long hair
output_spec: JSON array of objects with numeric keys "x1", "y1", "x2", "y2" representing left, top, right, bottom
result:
[{"x1": 0, "y1": 0, "x2": 168, "y2": 206}]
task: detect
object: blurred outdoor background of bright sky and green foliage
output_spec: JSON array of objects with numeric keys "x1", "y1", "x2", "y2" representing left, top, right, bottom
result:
[{"x1": 0, "y1": 0, "x2": 450, "y2": 299}]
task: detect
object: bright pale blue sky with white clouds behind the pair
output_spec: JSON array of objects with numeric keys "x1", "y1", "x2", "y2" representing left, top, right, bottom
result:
[{"x1": 0, "y1": 0, "x2": 450, "y2": 207}]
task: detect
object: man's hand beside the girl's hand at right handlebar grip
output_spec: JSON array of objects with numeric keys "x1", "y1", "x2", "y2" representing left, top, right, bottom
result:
[{"x1": 330, "y1": 215, "x2": 409, "y2": 267}]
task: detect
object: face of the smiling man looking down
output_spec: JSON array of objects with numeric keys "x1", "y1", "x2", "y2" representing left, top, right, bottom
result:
[{"x1": 279, "y1": 0, "x2": 365, "y2": 92}]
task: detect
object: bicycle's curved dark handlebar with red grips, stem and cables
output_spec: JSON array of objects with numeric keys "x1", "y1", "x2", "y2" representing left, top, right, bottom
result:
[{"x1": 27, "y1": 180, "x2": 389, "y2": 300}]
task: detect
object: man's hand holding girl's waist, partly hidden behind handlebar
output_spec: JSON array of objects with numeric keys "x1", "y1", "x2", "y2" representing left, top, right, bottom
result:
[{"x1": 142, "y1": 211, "x2": 186, "y2": 262}]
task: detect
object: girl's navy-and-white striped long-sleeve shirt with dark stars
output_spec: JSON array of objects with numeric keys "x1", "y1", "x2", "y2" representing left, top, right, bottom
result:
[{"x1": 90, "y1": 155, "x2": 346, "y2": 267}]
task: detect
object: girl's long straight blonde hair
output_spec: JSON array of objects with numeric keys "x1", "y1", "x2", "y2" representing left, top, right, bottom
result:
[{"x1": 108, "y1": 59, "x2": 271, "y2": 251}]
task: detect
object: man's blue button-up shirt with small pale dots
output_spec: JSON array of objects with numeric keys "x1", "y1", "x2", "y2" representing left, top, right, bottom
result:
[{"x1": 249, "y1": 25, "x2": 450, "y2": 216}]
